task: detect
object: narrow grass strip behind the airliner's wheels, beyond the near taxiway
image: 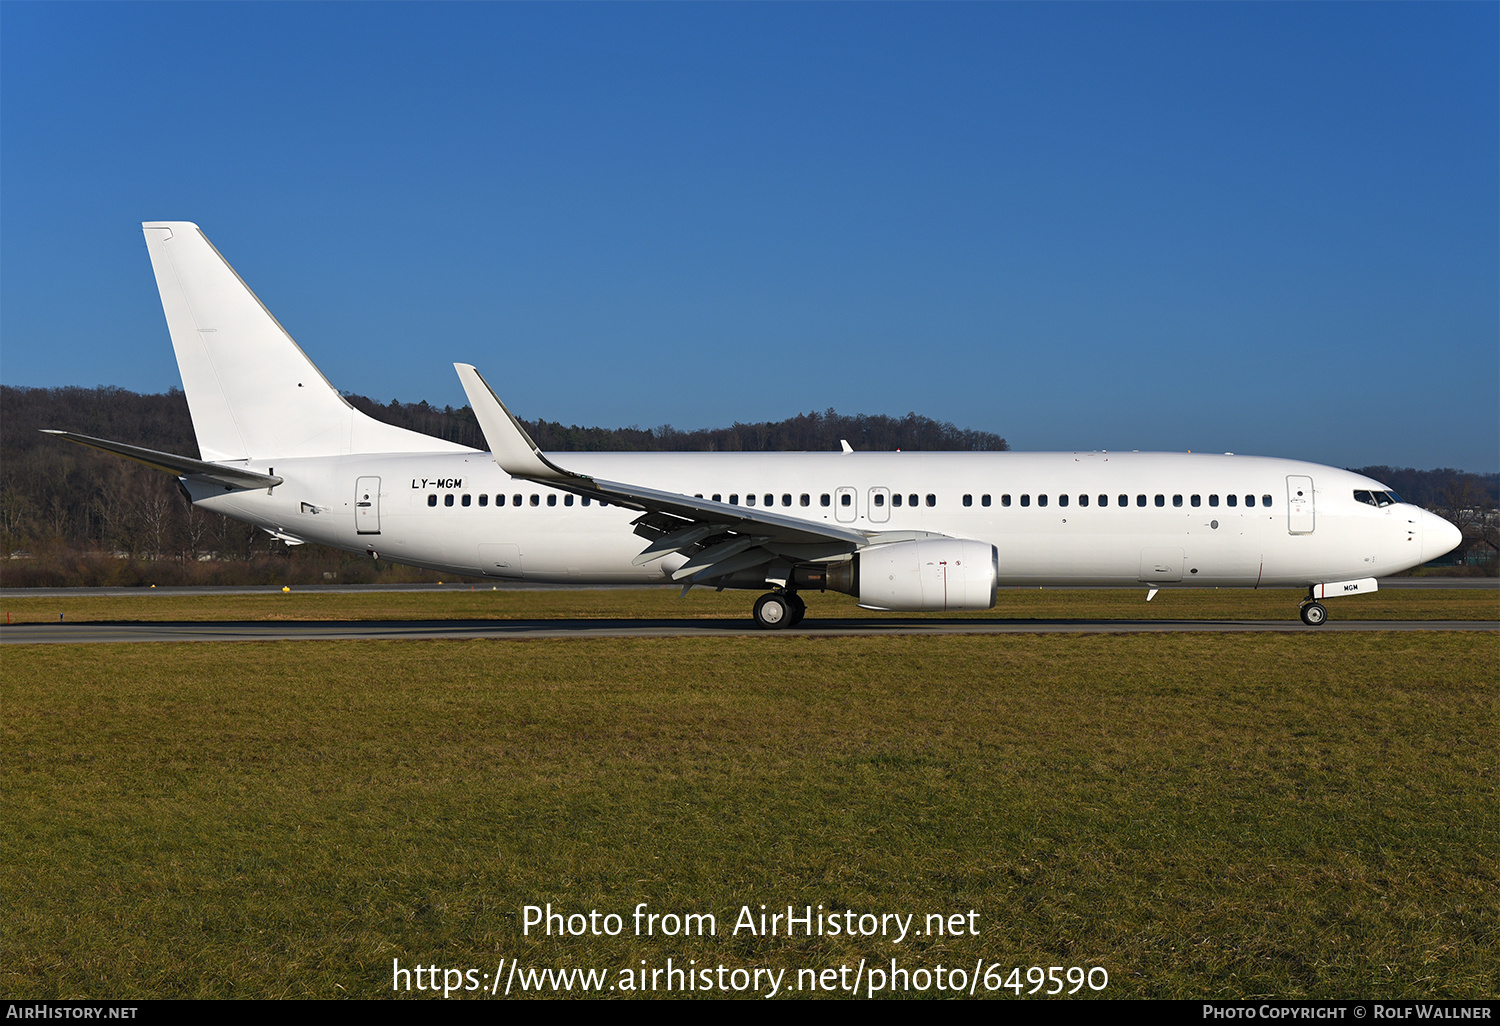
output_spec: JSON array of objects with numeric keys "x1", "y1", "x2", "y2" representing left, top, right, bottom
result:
[{"x1": 0, "y1": 587, "x2": 1500, "y2": 624}]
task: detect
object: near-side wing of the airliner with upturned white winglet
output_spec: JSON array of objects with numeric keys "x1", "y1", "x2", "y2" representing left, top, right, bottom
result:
[{"x1": 453, "y1": 363, "x2": 888, "y2": 587}]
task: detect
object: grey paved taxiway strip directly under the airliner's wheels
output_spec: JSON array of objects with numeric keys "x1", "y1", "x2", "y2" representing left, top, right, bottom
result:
[{"x1": 0, "y1": 618, "x2": 1500, "y2": 645}]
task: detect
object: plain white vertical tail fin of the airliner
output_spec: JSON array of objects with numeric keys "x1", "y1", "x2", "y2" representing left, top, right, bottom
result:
[{"x1": 141, "y1": 221, "x2": 473, "y2": 461}]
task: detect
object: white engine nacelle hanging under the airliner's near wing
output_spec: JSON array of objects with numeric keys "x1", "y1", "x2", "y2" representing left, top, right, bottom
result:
[{"x1": 858, "y1": 539, "x2": 1001, "y2": 611}]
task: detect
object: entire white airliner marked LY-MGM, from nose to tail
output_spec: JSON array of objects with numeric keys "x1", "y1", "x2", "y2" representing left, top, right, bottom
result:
[{"x1": 43, "y1": 222, "x2": 1460, "y2": 629}]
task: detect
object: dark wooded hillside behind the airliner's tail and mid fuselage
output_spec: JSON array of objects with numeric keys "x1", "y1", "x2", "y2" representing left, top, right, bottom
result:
[{"x1": 0, "y1": 386, "x2": 1008, "y2": 588}]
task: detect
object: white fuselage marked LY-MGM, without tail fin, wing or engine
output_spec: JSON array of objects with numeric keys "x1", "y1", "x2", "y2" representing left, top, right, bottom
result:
[{"x1": 189, "y1": 452, "x2": 1452, "y2": 587}]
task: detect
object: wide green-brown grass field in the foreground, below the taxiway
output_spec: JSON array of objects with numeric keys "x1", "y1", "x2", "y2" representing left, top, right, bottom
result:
[{"x1": 0, "y1": 630, "x2": 1500, "y2": 998}]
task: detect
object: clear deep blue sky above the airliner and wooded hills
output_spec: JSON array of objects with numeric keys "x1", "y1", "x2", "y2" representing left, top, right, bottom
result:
[{"x1": 0, "y1": 2, "x2": 1500, "y2": 471}]
